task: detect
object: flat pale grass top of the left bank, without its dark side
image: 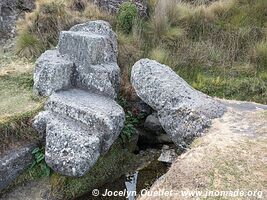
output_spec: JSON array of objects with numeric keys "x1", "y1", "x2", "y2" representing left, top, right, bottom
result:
[{"x1": 0, "y1": 50, "x2": 43, "y2": 123}]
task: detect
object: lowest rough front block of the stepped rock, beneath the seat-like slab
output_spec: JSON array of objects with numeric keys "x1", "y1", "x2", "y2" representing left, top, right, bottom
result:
[{"x1": 45, "y1": 113, "x2": 102, "y2": 177}]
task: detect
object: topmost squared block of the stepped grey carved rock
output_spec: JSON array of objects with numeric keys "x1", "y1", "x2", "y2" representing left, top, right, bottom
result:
[{"x1": 58, "y1": 20, "x2": 118, "y2": 66}]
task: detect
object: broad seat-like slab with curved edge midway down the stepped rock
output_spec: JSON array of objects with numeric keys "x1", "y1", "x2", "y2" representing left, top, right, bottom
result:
[{"x1": 45, "y1": 89, "x2": 125, "y2": 151}]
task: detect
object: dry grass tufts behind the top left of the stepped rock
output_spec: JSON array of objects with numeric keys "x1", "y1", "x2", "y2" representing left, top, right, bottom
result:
[{"x1": 16, "y1": 0, "x2": 112, "y2": 58}]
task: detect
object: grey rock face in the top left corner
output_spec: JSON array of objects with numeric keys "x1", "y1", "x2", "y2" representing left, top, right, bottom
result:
[{"x1": 0, "y1": 0, "x2": 35, "y2": 44}]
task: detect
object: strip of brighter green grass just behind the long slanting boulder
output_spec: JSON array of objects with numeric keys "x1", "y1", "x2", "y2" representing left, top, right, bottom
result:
[{"x1": 175, "y1": 66, "x2": 267, "y2": 104}]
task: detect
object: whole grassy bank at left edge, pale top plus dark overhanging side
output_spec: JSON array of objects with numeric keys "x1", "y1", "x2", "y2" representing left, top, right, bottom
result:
[{"x1": 0, "y1": 50, "x2": 43, "y2": 154}]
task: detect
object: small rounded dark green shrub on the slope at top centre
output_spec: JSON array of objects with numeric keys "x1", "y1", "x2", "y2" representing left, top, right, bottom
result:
[{"x1": 117, "y1": 2, "x2": 138, "y2": 34}]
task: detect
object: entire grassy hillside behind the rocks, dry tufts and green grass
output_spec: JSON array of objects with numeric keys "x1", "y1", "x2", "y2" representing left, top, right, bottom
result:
[{"x1": 16, "y1": 0, "x2": 267, "y2": 103}]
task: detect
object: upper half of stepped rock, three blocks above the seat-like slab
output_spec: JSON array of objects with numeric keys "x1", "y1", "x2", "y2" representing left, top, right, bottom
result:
[{"x1": 34, "y1": 20, "x2": 120, "y2": 99}]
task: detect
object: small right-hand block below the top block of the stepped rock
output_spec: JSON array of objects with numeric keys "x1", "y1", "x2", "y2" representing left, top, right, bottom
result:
[{"x1": 73, "y1": 63, "x2": 120, "y2": 99}]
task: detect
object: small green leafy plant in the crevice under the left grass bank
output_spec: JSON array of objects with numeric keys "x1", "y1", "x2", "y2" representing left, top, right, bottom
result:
[{"x1": 29, "y1": 147, "x2": 52, "y2": 178}]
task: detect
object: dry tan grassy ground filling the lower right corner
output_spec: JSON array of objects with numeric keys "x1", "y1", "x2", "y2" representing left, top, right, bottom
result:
[{"x1": 139, "y1": 101, "x2": 267, "y2": 200}]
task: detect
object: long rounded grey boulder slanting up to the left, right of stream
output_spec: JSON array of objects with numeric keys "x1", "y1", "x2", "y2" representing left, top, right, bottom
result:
[{"x1": 131, "y1": 59, "x2": 225, "y2": 147}]
